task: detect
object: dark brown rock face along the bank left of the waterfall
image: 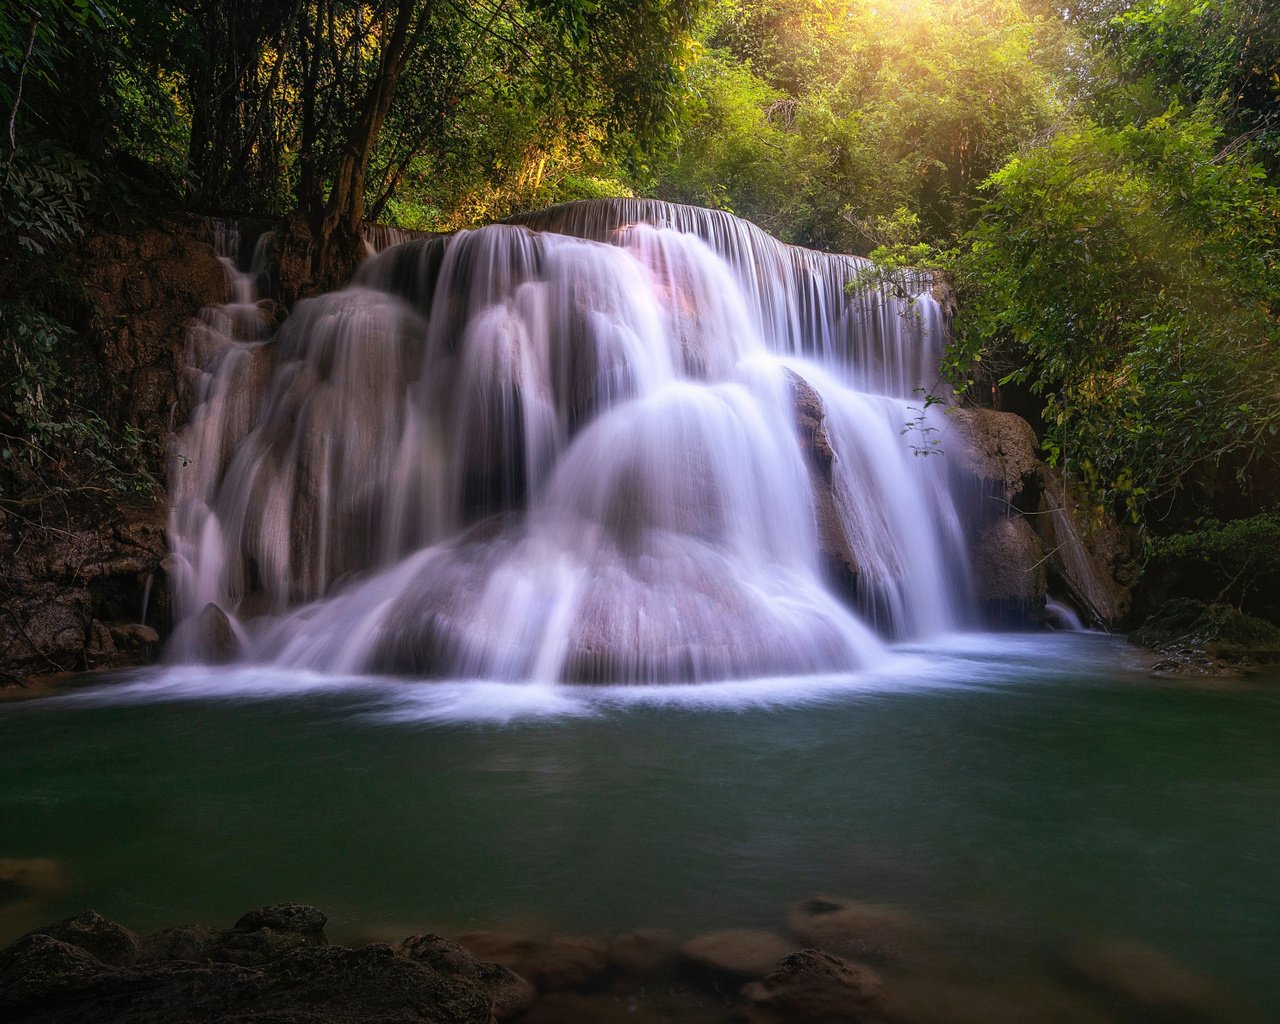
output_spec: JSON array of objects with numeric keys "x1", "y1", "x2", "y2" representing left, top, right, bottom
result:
[{"x1": 0, "y1": 220, "x2": 227, "y2": 685}]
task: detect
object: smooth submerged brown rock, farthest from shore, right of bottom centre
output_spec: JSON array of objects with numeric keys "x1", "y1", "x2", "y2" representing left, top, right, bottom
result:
[{"x1": 787, "y1": 896, "x2": 932, "y2": 960}]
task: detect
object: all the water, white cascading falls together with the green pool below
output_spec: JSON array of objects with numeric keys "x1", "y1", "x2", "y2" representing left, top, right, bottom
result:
[{"x1": 0, "y1": 201, "x2": 1280, "y2": 1024}]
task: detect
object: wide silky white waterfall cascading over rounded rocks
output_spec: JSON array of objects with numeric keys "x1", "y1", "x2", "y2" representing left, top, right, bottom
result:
[{"x1": 173, "y1": 200, "x2": 968, "y2": 682}]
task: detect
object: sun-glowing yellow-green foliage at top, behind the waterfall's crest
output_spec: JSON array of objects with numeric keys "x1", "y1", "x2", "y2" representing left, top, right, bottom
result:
[{"x1": 658, "y1": 0, "x2": 1061, "y2": 252}]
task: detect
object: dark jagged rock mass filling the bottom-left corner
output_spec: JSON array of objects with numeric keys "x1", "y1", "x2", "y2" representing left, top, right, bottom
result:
[{"x1": 0, "y1": 904, "x2": 531, "y2": 1024}]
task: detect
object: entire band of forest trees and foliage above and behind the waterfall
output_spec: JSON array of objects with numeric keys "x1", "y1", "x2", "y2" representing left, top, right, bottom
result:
[{"x1": 0, "y1": 0, "x2": 1280, "y2": 540}]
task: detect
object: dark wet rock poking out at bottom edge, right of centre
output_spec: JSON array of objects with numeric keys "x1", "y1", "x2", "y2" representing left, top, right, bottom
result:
[{"x1": 742, "y1": 950, "x2": 882, "y2": 1024}]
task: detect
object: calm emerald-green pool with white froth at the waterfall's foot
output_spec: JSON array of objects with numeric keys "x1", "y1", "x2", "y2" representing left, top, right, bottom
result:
[{"x1": 0, "y1": 634, "x2": 1280, "y2": 1016}]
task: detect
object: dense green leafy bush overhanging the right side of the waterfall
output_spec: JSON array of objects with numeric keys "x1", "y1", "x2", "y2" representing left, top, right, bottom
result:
[{"x1": 951, "y1": 108, "x2": 1280, "y2": 518}]
